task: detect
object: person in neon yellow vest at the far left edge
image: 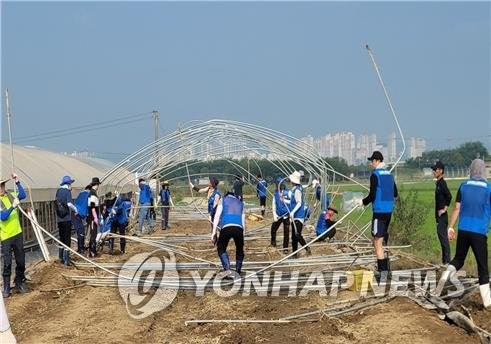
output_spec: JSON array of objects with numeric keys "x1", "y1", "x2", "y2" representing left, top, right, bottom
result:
[{"x1": 0, "y1": 173, "x2": 27, "y2": 297}]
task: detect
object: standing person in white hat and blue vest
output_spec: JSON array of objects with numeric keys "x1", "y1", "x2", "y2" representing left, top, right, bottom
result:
[{"x1": 288, "y1": 171, "x2": 311, "y2": 258}]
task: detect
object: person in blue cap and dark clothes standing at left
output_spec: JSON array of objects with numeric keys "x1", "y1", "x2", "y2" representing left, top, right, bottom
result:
[{"x1": 55, "y1": 176, "x2": 77, "y2": 266}]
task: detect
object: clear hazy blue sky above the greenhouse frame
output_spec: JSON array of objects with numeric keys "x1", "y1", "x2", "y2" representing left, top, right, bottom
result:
[{"x1": 1, "y1": 2, "x2": 491, "y2": 160}]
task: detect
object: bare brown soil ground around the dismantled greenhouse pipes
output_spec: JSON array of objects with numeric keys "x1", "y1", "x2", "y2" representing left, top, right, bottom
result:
[{"x1": 5, "y1": 221, "x2": 491, "y2": 344}]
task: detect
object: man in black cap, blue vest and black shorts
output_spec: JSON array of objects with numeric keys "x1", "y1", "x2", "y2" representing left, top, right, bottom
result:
[{"x1": 362, "y1": 151, "x2": 397, "y2": 273}]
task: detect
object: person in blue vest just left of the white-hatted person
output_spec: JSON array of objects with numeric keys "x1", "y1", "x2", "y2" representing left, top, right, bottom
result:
[{"x1": 271, "y1": 177, "x2": 291, "y2": 251}]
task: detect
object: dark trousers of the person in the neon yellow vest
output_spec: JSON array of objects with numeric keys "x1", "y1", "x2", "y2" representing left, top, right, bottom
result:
[{"x1": 1, "y1": 233, "x2": 26, "y2": 284}]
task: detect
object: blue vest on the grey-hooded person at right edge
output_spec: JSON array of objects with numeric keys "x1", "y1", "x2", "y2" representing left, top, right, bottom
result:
[{"x1": 459, "y1": 178, "x2": 491, "y2": 235}]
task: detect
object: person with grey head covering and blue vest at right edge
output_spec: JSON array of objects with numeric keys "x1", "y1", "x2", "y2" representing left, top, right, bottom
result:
[{"x1": 436, "y1": 159, "x2": 491, "y2": 309}]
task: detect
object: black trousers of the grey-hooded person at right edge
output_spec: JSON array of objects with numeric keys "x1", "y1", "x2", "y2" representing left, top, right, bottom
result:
[{"x1": 450, "y1": 230, "x2": 489, "y2": 285}]
